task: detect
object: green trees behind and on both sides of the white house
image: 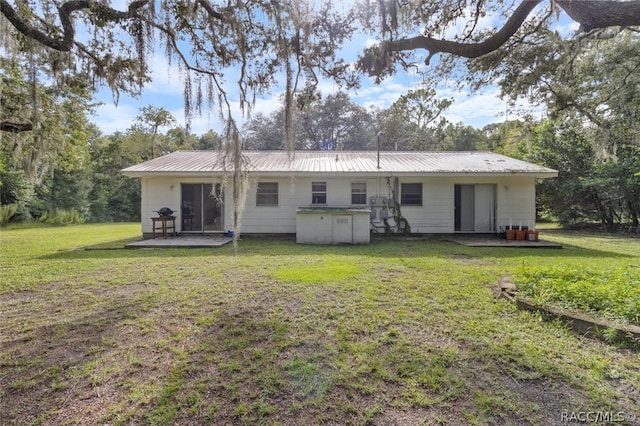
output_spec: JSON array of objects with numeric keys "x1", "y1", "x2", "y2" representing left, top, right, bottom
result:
[{"x1": 0, "y1": 24, "x2": 640, "y2": 230}]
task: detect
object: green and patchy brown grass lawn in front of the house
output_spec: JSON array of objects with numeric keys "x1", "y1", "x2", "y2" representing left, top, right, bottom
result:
[{"x1": 0, "y1": 224, "x2": 640, "y2": 425}]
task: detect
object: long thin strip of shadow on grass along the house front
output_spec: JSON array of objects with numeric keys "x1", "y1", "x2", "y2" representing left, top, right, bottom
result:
[{"x1": 40, "y1": 236, "x2": 637, "y2": 259}]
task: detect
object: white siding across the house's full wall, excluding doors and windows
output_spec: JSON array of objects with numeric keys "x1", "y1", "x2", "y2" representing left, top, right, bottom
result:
[{"x1": 141, "y1": 176, "x2": 535, "y2": 235}]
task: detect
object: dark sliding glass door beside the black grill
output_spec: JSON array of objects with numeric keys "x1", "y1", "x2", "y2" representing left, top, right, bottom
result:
[{"x1": 181, "y1": 183, "x2": 224, "y2": 232}]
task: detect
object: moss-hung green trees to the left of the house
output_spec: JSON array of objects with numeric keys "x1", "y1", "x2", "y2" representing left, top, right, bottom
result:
[{"x1": 0, "y1": 58, "x2": 220, "y2": 223}]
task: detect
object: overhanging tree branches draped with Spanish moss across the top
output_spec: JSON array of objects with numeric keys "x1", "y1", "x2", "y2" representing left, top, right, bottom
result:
[{"x1": 0, "y1": 0, "x2": 640, "y2": 138}]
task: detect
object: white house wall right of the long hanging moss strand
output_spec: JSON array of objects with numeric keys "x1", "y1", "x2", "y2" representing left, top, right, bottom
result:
[{"x1": 235, "y1": 176, "x2": 535, "y2": 234}]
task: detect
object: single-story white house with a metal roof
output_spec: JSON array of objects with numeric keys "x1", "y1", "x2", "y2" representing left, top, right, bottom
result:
[{"x1": 122, "y1": 151, "x2": 558, "y2": 243}]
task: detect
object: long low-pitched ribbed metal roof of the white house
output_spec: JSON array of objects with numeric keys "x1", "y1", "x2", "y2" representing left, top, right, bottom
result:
[{"x1": 122, "y1": 151, "x2": 558, "y2": 178}]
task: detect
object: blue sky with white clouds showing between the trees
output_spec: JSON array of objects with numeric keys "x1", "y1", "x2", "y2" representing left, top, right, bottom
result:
[{"x1": 92, "y1": 2, "x2": 572, "y2": 135}]
